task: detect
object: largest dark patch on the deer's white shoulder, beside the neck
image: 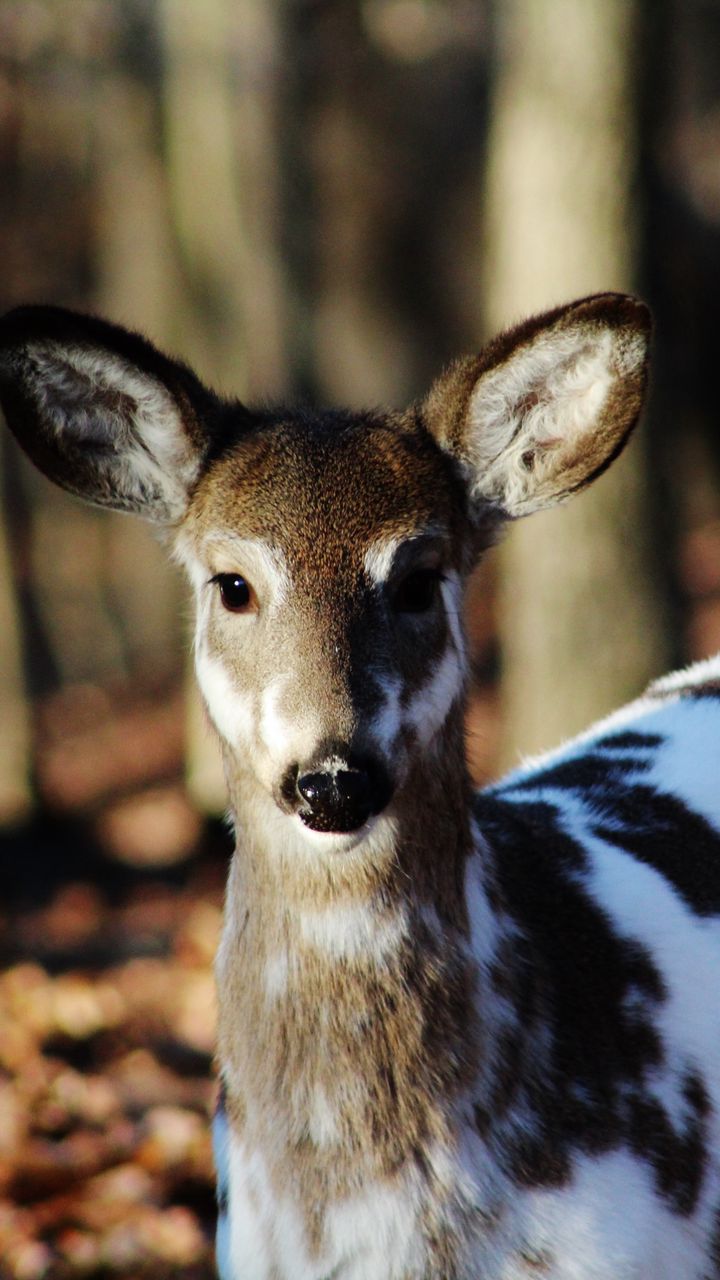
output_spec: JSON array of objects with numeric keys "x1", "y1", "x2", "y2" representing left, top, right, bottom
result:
[{"x1": 475, "y1": 783, "x2": 707, "y2": 1213}]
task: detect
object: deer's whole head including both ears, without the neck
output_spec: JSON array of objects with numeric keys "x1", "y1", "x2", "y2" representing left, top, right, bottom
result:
[{"x1": 0, "y1": 294, "x2": 650, "y2": 840}]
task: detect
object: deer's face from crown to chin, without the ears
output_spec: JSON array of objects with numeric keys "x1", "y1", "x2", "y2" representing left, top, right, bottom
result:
[{"x1": 177, "y1": 415, "x2": 468, "y2": 835}]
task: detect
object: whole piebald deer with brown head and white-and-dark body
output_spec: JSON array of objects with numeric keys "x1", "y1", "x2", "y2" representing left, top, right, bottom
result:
[{"x1": 0, "y1": 293, "x2": 720, "y2": 1280}]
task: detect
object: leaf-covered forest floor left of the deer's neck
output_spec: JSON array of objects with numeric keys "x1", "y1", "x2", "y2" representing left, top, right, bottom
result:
[{"x1": 0, "y1": 820, "x2": 229, "y2": 1280}]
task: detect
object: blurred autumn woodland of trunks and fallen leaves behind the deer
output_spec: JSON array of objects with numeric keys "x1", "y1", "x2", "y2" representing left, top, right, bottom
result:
[{"x1": 0, "y1": 0, "x2": 720, "y2": 1280}]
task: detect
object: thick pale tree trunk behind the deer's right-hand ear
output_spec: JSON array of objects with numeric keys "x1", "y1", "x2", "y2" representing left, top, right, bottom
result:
[{"x1": 486, "y1": 0, "x2": 671, "y2": 763}]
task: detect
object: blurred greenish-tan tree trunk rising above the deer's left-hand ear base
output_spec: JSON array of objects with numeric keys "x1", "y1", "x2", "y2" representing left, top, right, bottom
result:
[{"x1": 159, "y1": 0, "x2": 286, "y2": 813}]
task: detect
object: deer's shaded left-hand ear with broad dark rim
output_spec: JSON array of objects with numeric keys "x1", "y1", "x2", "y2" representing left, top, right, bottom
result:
[{"x1": 0, "y1": 307, "x2": 217, "y2": 524}]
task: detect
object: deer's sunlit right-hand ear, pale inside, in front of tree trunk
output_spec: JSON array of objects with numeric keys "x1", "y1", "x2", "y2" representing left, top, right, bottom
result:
[{"x1": 424, "y1": 293, "x2": 651, "y2": 520}]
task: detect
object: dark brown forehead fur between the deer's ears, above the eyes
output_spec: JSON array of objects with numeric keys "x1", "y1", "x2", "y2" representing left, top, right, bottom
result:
[{"x1": 186, "y1": 401, "x2": 465, "y2": 561}]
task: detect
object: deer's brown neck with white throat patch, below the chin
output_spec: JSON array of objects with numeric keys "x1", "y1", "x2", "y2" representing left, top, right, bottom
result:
[{"x1": 212, "y1": 717, "x2": 478, "y2": 1177}]
